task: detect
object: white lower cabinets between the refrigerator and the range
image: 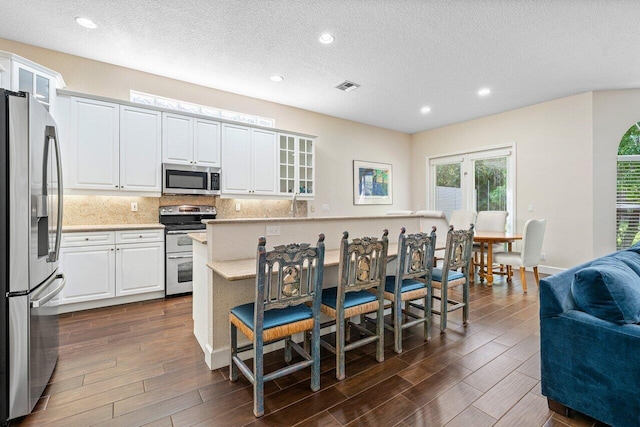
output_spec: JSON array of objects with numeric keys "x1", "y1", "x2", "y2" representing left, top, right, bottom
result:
[{"x1": 58, "y1": 229, "x2": 164, "y2": 305}]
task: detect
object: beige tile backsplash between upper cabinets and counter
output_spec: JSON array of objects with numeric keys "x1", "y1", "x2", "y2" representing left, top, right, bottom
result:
[{"x1": 63, "y1": 195, "x2": 307, "y2": 226}]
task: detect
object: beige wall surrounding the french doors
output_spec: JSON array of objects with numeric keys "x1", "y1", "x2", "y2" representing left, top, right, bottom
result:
[{"x1": 411, "y1": 93, "x2": 594, "y2": 267}]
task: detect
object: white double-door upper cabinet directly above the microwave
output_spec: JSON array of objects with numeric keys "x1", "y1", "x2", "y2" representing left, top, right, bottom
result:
[{"x1": 162, "y1": 113, "x2": 220, "y2": 167}]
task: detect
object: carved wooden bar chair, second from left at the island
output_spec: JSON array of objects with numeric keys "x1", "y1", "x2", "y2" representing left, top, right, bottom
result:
[{"x1": 321, "y1": 230, "x2": 389, "y2": 380}]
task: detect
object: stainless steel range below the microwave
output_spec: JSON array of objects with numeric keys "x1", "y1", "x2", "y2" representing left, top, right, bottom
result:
[{"x1": 160, "y1": 205, "x2": 216, "y2": 296}]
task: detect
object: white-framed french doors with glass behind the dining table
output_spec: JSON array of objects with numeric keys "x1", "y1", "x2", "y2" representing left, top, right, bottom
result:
[{"x1": 427, "y1": 145, "x2": 516, "y2": 230}]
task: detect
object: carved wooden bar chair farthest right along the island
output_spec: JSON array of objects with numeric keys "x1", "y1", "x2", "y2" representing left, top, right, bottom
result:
[{"x1": 431, "y1": 225, "x2": 473, "y2": 333}]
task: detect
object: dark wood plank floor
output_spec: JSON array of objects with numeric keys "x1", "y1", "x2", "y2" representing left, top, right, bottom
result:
[{"x1": 12, "y1": 277, "x2": 594, "y2": 427}]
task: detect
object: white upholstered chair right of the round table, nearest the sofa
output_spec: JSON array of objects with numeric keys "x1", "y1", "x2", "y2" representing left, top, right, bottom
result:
[{"x1": 493, "y1": 219, "x2": 547, "y2": 292}]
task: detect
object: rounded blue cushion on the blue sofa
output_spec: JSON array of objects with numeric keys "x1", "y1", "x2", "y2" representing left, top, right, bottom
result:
[{"x1": 571, "y1": 257, "x2": 640, "y2": 324}]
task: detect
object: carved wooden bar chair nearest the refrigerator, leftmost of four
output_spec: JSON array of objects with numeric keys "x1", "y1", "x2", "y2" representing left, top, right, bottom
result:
[{"x1": 229, "y1": 234, "x2": 324, "y2": 417}]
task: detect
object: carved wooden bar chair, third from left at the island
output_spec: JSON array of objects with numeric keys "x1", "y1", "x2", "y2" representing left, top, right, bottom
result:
[{"x1": 384, "y1": 227, "x2": 436, "y2": 353}]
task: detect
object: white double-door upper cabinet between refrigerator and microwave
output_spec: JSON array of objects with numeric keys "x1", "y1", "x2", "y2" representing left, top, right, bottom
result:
[{"x1": 58, "y1": 97, "x2": 162, "y2": 195}]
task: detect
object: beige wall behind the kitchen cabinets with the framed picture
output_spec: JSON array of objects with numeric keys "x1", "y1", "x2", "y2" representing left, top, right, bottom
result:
[{"x1": 0, "y1": 39, "x2": 412, "y2": 221}]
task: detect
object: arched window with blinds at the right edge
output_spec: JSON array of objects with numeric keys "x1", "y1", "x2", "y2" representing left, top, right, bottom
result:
[{"x1": 616, "y1": 122, "x2": 640, "y2": 249}]
